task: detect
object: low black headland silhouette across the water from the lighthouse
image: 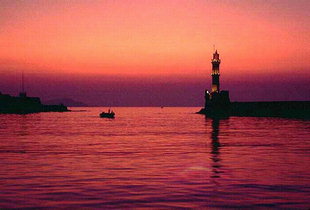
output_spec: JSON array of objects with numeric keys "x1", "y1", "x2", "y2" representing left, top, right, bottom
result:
[{"x1": 0, "y1": 92, "x2": 69, "y2": 114}]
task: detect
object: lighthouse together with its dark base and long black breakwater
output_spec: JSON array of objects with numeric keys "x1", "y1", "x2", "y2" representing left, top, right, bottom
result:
[{"x1": 197, "y1": 50, "x2": 310, "y2": 119}]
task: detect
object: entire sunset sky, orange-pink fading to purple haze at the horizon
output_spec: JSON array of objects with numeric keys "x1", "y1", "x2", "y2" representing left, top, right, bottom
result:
[{"x1": 0, "y1": 0, "x2": 310, "y2": 106}]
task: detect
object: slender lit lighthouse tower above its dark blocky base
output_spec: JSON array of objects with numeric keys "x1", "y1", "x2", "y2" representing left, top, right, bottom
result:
[{"x1": 211, "y1": 50, "x2": 221, "y2": 93}]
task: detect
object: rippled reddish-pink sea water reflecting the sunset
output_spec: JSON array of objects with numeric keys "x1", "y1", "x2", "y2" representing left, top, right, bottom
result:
[{"x1": 0, "y1": 108, "x2": 310, "y2": 209}]
